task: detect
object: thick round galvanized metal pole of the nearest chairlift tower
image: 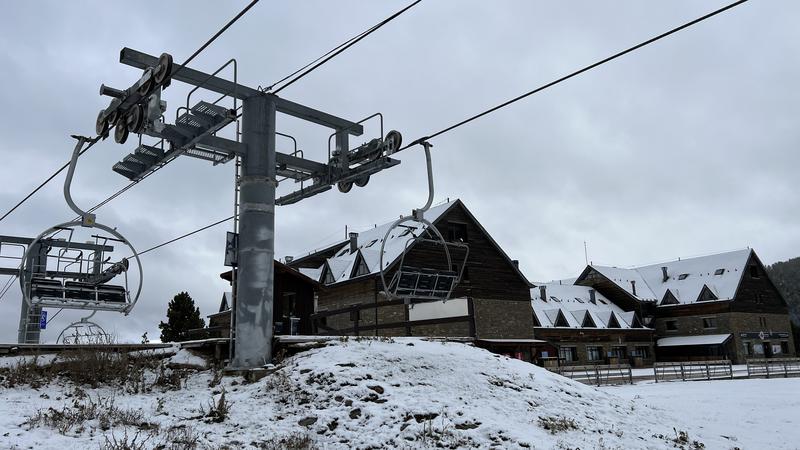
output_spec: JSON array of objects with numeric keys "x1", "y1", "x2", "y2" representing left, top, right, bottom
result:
[{"x1": 232, "y1": 94, "x2": 277, "y2": 369}]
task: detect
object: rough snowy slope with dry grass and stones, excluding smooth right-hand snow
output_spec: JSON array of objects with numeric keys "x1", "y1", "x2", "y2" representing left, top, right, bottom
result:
[{"x1": 0, "y1": 338, "x2": 712, "y2": 449}]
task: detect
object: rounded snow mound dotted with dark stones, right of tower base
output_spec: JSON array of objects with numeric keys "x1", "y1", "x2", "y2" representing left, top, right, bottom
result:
[{"x1": 248, "y1": 338, "x2": 688, "y2": 449}]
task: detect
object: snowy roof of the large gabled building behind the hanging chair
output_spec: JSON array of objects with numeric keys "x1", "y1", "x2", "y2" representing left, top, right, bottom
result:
[{"x1": 300, "y1": 199, "x2": 458, "y2": 283}]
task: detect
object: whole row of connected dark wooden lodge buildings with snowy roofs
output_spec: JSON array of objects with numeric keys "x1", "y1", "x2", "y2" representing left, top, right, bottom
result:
[{"x1": 206, "y1": 200, "x2": 796, "y2": 366}]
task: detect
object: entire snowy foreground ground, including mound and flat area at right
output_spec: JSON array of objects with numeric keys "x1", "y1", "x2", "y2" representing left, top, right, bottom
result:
[{"x1": 0, "y1": 338, "x2": 800, "y2": 450}]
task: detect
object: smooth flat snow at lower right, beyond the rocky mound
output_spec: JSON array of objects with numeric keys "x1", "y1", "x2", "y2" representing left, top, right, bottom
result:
[{"x1": 601, "y1": 380, "x2": 800, "y2": 450}]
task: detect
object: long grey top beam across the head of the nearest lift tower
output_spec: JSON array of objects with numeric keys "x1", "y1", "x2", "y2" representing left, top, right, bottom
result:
[{"x1": 119, "y1": 47, "x2": 364, "y2": 136}]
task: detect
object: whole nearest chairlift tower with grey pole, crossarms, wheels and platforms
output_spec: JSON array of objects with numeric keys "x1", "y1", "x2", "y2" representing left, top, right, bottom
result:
[{"x1": 97, "y1": 48, "x2": 401, "y2": 369}]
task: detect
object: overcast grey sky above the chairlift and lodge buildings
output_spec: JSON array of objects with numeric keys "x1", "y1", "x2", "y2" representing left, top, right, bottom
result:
[{"x1": 0, "y1": 0, "x2": 800, "y2": 342}]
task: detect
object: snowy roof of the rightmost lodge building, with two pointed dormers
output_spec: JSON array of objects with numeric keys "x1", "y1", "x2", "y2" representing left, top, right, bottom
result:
[{"x1": 591, "y1": 249, "x2": 751, "y2": 305}]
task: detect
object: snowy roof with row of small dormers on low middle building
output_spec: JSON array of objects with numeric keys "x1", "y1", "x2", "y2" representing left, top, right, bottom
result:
[{"x1": 531, "y1": 282, "x2": 639, "y2": 329}]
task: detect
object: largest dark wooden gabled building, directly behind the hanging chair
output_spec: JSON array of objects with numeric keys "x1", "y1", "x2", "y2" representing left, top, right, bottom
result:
[{"x1": 289, "y1": 200, "x2": 537, "y2": 360}]
